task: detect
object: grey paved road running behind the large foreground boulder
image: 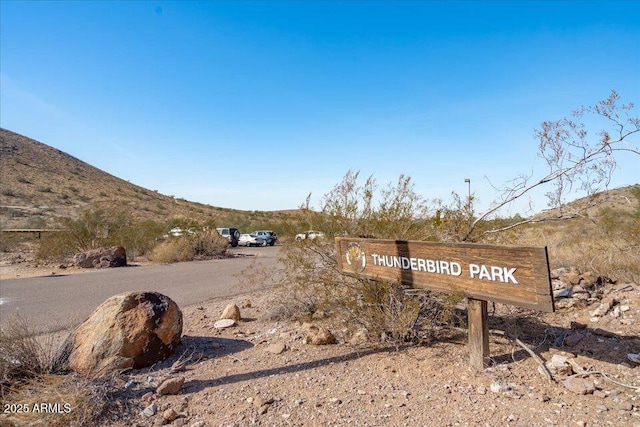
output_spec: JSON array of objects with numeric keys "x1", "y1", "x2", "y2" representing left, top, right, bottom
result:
[{"x1": 0, "y1": 246, "x2": 280, "y2": 332}]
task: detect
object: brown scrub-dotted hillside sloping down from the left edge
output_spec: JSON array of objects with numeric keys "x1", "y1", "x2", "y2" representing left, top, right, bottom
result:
[{"x1": 0, "y1": 128, "x2": 296, "y2": 231}]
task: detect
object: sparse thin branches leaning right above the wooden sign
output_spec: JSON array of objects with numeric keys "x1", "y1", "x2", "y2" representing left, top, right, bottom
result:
[{"x1": 462, "y1": 90, "x2": 640, "y2": 241}]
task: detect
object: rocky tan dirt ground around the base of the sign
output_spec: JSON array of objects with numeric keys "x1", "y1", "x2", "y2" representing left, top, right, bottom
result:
[{"x1": 0, "y1": 256, "x2": 640, "y2": 427}]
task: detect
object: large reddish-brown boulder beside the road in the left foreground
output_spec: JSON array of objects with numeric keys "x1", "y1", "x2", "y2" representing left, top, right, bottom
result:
[{"x1": 58, "y1": 292, "x2": 182, "y2": 378}]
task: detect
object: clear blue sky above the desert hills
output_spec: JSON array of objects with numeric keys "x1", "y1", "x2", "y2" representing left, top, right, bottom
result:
[{"x1": 0, "y1": 0, "x2": 640, "y2": 214}]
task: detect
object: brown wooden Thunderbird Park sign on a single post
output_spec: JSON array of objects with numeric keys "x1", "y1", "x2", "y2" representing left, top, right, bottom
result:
[{"x1": 336, "y1": 237, "x2": 554, "y2": 369}]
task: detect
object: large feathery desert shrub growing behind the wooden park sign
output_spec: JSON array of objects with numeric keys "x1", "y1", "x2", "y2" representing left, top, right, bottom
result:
[{"x1": 277, "y1": 172, "x2": 460, "y2": 344}]
